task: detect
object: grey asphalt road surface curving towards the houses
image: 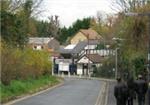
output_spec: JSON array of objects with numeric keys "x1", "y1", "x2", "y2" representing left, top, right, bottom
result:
[{"x1": 13, "y1": 78, "x2": 104, "y2": 105}]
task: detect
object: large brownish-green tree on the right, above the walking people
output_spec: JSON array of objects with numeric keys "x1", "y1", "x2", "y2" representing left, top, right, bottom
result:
[{"x1": 112, "y1": 0, "x2": 150, "y2": 75}]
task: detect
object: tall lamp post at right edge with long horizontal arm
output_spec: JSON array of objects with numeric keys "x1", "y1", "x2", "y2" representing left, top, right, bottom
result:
[{"x1": 125, "y1": 12, "x2": 150, "y2": 80}]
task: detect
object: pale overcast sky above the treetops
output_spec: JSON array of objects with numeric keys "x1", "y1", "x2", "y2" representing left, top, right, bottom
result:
[{"x1": 40, "y1": 0, "x2": 114, "y2": 27}]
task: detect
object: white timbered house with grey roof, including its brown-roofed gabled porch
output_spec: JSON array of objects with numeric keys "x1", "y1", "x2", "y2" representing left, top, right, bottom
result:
[{"x1": 56, "y1": 41, "x2": 108, "y2": 75}]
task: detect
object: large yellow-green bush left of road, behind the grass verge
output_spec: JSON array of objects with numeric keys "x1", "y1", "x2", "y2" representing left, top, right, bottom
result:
[{"x1": 1, "y1": 46, "x2": 51, "y2": 85}]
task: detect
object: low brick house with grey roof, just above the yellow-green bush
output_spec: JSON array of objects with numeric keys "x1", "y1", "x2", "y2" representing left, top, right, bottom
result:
[{"x1": 28, "y1": 37, "x2": 60, "y2": 52}]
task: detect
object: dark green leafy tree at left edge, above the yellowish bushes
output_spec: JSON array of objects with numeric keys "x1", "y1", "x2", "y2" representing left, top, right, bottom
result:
[{"x1": 1, "y1": 11, "x2": 27, "y2": 48}]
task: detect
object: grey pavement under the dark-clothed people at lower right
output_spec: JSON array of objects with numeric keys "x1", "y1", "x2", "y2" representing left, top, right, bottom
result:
[{"x1": 107, "y1": 82, "x2": 148, "y2": 105}]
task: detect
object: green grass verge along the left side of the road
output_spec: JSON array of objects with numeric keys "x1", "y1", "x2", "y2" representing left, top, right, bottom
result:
[{"x1": 0, "y1": 75, "x2": 60, "y2": 103}]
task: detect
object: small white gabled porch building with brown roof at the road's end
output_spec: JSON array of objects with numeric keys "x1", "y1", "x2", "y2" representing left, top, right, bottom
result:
[{"x1": 77, "y1": 54, "x2": 104, "y2": 75}]
